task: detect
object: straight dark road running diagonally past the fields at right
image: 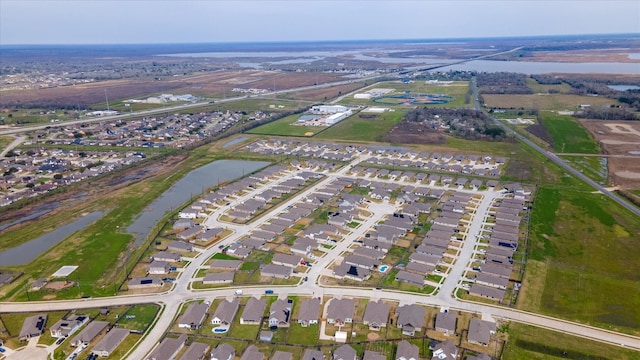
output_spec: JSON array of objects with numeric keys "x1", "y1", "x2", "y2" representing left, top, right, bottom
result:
[{"x1": 471, "y1": 78, "x2": 640, "y2": 216}]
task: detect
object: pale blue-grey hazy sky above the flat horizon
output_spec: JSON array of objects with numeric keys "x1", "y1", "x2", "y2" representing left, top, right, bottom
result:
[{"x1": 0, "y1": 0, "x2": 640, "y2": 45}]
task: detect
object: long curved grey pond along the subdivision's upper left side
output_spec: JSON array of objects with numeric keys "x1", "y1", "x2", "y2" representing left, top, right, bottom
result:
[{"x1": 127, "y1": 160, "x2": 270, "y2": 246}]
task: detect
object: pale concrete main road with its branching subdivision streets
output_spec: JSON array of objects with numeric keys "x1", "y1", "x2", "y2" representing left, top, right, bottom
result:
[{"x1": 0, "y1": 157, "x2": 640, "y2": 360}]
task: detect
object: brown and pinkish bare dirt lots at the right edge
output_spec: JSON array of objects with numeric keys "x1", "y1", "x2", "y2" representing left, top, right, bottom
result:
[{"x1": 580, "y1": 120, "x2": 640, "y2": 189}]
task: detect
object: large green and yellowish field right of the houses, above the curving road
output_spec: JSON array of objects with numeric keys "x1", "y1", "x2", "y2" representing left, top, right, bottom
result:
[{"x1": 517, "y1": 186, "x2": 640, "y2": 335}]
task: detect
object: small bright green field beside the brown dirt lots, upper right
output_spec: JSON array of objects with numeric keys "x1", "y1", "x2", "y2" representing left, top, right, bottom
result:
[{"x1": 539, "y1": 112, "x2": 601, "y2": 154}]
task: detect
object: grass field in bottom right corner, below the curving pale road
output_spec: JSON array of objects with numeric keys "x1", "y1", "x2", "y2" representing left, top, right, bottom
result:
[{"x1": 501, "y1": 323, "x2": 640, "y2": 360}]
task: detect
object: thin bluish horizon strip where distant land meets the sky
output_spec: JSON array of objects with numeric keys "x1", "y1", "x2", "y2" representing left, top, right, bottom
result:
[{"x1": 0, "y1": 32, "x2": 640, "y2": 47}]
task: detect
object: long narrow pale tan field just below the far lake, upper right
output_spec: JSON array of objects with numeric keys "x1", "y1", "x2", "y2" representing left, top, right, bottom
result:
[{"x1": 482, "y1": 94, "x2": 618, "y2": 110}]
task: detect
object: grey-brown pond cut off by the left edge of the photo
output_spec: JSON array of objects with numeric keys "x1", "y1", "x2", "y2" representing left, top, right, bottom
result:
[{"x1": 0, "y1": 211, "x2": 104, "y2": 266}]
